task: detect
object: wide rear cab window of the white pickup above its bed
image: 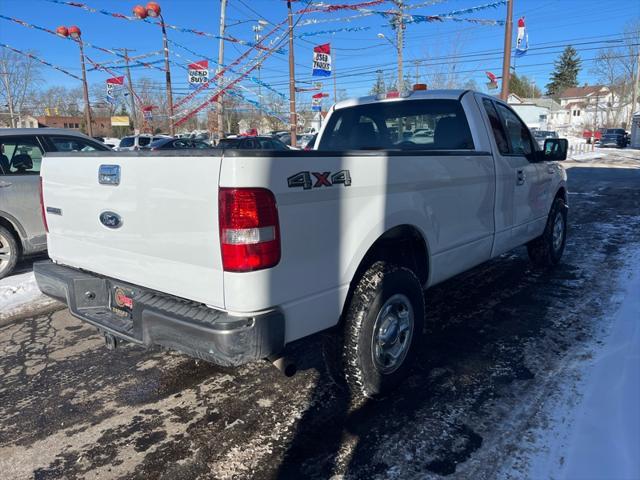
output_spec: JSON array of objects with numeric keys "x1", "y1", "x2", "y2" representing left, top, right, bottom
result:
[{"x1": 319, "y1": 99, "x2": 475, "y2": 150}]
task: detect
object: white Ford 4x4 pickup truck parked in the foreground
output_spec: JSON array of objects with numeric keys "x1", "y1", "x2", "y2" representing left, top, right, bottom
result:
[{"x1": 34, "y1": 91, "x2": 567, "y2": 397}]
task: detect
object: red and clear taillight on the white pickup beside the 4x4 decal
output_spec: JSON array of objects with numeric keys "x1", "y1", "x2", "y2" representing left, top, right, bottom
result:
[{"x1": 218, "y1": 188, "x2": 280, "y2": 272}]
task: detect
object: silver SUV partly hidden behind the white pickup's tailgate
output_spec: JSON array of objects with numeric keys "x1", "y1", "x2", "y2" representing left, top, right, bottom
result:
[{"x1": 0, "y1": 128, "x2": 110, "y2": 278}]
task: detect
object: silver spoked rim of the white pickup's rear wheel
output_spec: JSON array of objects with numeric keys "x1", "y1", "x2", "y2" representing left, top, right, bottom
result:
[{"x1": 371, "y1": 294, "x2": 415, "y2": 374}]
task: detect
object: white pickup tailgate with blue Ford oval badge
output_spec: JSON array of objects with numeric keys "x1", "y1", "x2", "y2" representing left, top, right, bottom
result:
[{"x1": 41, "y1": 152, "x2": 224, "y2": 308}]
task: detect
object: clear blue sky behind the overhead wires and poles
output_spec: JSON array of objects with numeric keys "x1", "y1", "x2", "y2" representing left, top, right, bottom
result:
[{"x1": 0, "y1": 0, "x2": 640, "y2": 109}]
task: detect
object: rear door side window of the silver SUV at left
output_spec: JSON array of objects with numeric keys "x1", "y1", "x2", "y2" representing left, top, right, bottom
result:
[{"x1": 0, "y1": 136, "x2": 43, "y2": 175}]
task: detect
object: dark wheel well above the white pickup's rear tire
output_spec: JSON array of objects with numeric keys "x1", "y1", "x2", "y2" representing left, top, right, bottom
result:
[{"x1": 353, "y1": 225, "x2": 429, "y2": 285}]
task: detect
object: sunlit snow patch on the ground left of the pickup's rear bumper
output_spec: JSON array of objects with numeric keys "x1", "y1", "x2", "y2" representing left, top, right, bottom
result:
[{"x1": 0, "y1": 272, "x2": 60, "y2": 325}]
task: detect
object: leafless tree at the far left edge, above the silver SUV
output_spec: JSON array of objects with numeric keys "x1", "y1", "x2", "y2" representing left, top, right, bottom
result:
[{"x1": 0, "y1": 49, "x2": 42, "y2": 128}]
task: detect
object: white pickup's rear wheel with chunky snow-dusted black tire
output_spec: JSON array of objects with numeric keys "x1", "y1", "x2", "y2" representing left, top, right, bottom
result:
[{"x1": 340, "y1": 261, "x2": 424, "y2": 401}]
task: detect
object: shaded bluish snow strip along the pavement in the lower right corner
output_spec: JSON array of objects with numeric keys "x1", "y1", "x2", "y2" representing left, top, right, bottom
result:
[{"x1": 516, "y1": 250, "x2": 640, "y2": 480}]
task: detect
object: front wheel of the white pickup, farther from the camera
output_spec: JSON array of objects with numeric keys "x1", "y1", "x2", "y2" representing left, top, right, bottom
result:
[{"x1": 527, "y1": 198, "x2": 568, "y2": 268}]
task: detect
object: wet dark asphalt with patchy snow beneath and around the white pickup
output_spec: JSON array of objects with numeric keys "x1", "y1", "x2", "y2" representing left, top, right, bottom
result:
[{"x1": 0, "y1": 160, "x2": 640, "y2": 479}]
